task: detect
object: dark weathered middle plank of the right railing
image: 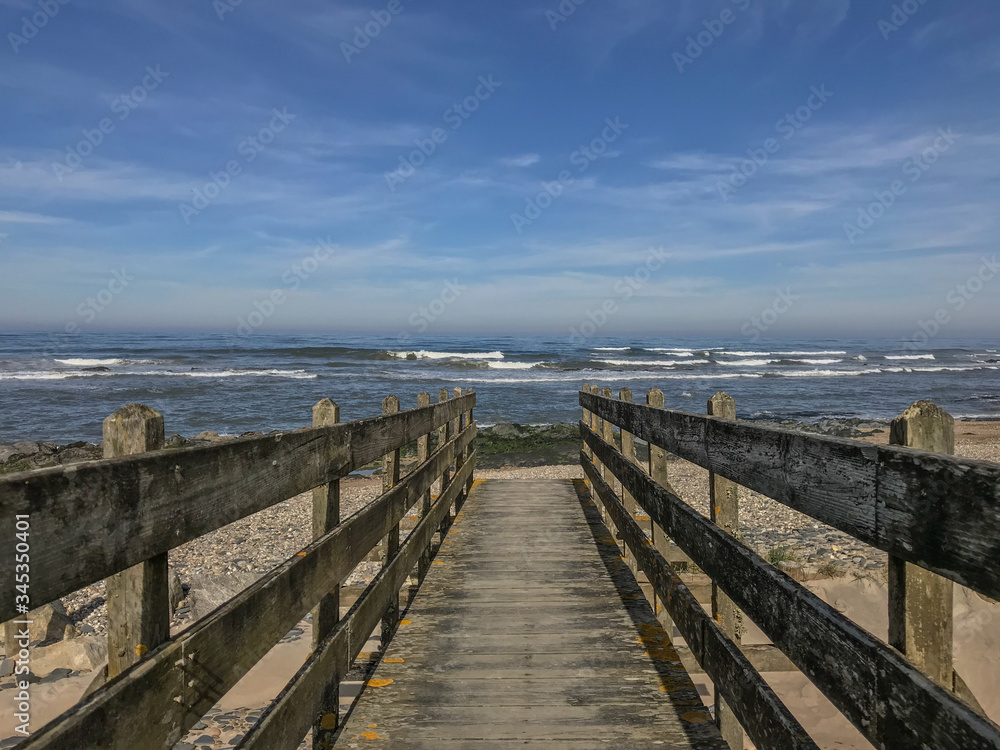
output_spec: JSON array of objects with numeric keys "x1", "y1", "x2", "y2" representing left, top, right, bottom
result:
[{"x1": 580, "y1": 423, "x2": 1000, "y2": 750}]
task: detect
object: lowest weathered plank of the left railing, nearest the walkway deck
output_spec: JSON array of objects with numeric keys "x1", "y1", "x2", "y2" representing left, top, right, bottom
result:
[{"x1": 237, "y1": 453, "x2": 475, "y2": 750}]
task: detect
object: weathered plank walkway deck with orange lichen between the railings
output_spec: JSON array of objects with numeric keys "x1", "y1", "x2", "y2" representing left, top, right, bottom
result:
[{"x1": 337, "y1": 480, "x2": 726, "y2": 750}]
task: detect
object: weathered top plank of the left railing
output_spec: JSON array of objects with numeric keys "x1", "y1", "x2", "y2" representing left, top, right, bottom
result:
[{"x1": 0, "y1": 394, "x2": 476, "y2": 621}]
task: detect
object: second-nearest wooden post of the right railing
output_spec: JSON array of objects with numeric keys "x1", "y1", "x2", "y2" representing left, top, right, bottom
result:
[{"x1": 708, "y1": 391, "x2": 743, "y2": 750}]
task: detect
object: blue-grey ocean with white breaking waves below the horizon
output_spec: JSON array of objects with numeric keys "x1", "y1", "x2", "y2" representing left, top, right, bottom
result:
[{"x1": 0, "y1": 333, "x2": 1000, "y2": 443}]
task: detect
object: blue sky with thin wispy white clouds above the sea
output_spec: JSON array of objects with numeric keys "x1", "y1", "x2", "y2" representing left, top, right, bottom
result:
[{"x1": 0, "y1": 0, "x2": 1000, "y2": 337}]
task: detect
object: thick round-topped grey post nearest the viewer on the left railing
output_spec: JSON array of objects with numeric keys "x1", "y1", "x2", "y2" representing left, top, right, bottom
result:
[{"x1": 103, "y1": 404, "x2": 170, "y2": 679}]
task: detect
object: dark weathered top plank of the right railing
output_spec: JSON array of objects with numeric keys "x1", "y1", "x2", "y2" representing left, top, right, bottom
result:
[{"x1": 580, "y1": 393, "x2": 1000, "y2": 599}]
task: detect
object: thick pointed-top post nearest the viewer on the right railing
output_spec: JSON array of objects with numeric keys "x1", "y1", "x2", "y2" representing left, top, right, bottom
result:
[{"x1": 889, "y1": 401, "x2": 955, "y2": 690}]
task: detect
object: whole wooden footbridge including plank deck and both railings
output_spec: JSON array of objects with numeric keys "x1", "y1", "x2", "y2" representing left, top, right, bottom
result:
[{"x1": 0, "y1": 385, "x2": 1000, "y2": 750}]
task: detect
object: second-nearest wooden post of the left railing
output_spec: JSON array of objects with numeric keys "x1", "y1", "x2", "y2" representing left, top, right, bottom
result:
[{"x1": 313, "y1": 398, "x2": 340, "y2": 750}]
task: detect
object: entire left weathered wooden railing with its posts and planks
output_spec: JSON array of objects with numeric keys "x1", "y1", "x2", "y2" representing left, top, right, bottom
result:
[{"x1": 0, "y1": 388, "x2": 476, "y2": 750}]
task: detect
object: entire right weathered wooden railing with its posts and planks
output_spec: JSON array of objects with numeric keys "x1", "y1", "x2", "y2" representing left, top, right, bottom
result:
[{"x1": 580, "y1": 384, "x2": 1000, "y2": 750}]
